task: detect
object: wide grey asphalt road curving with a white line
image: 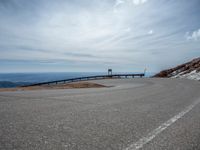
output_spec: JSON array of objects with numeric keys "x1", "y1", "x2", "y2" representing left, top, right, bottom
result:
[{"x1": 0, "y1": 79, "x2": 200, "y2": 150}]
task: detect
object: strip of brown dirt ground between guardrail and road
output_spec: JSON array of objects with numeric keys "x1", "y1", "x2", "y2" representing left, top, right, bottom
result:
[{"x1": 0, "y1": 82, "x2": 106, "y2": 92}]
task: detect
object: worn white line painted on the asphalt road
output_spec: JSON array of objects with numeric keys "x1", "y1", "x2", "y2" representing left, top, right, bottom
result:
[{"x1": 125, "y1": 100, "x2": 200, "y2": 150}]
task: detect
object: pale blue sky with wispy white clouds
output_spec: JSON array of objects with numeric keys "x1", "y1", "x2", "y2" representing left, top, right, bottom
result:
[{"x1": 0, "y1": 0, "x2": 200, "y2": 72}]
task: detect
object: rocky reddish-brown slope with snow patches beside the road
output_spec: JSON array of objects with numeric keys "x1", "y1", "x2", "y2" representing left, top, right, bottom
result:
[{"x1": 154, "y1": 57, "x2": 200, "y2": 81}]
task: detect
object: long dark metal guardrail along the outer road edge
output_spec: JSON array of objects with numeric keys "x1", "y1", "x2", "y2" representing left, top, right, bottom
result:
[{"x1": 21, "y1": 73, "x2": 145, "y2": 87}]
